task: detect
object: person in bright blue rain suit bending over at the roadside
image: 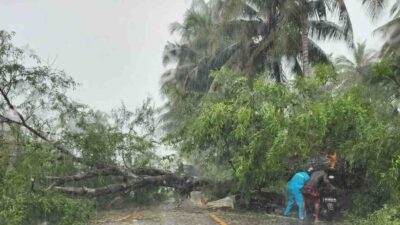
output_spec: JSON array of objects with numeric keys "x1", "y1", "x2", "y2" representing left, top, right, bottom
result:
[{"x1": 284, "y1": 167, "x2": 314, "y2": 220}]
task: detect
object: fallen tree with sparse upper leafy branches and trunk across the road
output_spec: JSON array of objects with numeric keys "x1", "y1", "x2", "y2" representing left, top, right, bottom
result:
[{"x1": 0, "y1": 31, "x2": 204, "y2": 198}]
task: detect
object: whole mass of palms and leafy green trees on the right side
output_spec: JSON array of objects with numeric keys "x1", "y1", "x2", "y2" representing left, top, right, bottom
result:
[{"x1": 162, "y1": 0, "x2": 400, "y2": 224}]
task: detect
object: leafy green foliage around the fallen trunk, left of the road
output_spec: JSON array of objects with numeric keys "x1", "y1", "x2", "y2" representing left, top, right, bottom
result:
[{"x1": 0, "y1": 31, "x2": 159, "y2": 225}]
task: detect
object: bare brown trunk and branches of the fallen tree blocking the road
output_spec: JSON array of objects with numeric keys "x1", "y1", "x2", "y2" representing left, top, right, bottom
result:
[{"x1": 0, "y1": 87, "x2": 204, "y2": 198}]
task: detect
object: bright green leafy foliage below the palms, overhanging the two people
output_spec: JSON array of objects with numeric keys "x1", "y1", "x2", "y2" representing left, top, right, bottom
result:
[{"x1": 166, "y1": 60, "x2": 400, "y2": 222}]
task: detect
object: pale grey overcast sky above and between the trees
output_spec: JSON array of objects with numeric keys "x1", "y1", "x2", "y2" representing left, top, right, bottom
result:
[{"x1": 0, "y1": 0, "x2": 394, "y2": 111}]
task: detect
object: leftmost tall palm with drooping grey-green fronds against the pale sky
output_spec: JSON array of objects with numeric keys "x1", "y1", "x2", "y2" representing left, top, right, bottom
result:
[{"x1": 161, "y1": 0, "x2": 230, "y2": 131}]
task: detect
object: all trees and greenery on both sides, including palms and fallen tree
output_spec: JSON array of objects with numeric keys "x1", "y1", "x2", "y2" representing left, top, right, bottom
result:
[{"x1": 0, "y1": 0, "x2": 400, "y2": 225}]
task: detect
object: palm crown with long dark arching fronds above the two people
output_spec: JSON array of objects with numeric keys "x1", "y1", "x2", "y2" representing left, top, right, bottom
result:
[{"x1": 219, "y1": 0, "x2": 353, "y2": 78}]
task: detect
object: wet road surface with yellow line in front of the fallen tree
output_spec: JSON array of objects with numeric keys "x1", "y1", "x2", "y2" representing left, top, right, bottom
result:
[{"x1": 94, "y1": 200, "x2": 340, "y2": 225}]
